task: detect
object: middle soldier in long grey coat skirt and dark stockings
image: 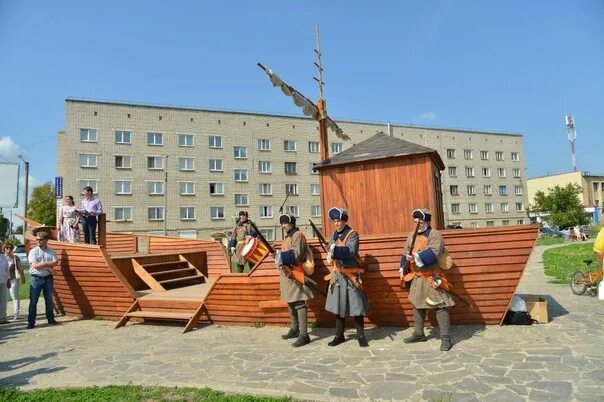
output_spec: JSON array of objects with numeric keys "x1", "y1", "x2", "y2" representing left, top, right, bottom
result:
[{"x1": 325, "y1": 207, "x2": 369, "y2": 347}]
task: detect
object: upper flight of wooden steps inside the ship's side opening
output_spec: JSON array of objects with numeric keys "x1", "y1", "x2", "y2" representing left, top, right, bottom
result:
[{"x1": 132, "y1": 255, "x2": 207, "y2": 292}]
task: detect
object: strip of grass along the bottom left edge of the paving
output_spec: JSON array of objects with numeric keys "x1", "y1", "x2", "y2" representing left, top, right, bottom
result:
[{"x1": 0, "y1": 385, "x2": 292, "y2": 402}]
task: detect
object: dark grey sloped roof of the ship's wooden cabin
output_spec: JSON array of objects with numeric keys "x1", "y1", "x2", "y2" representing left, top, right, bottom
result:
[{"x1": 315, "y1": 133, "x2": 445, "y2": 170}]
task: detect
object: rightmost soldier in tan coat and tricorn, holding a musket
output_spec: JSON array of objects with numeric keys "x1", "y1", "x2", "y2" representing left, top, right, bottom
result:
[{"x1": 400, "y1": 209, "x2": 455, "y2": 351}]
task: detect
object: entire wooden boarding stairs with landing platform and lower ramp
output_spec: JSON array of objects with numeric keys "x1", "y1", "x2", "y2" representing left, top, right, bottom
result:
[{"x1": 115, "y1": 254, "x2": 215, "y2": 333}]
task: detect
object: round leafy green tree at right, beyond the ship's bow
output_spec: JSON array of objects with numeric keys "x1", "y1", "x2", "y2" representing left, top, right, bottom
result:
[{"x1": 529, "y1": 183, "x2": 589, "y2": 228}]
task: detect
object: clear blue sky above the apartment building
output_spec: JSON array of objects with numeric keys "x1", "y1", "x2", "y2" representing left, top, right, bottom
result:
[{"x1": 0, "y1": 0, "x2": 604, "y2": 210}]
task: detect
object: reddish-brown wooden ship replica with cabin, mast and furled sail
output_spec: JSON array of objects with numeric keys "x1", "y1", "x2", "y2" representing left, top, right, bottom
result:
[{"x1": 26, "y1": 32, "x2": 538, "y2": 332}]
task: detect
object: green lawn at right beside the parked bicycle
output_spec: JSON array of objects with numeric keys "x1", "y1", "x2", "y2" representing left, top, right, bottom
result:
[{"x1": 543, "y1": 243, "x2": 599, "y2": 283}]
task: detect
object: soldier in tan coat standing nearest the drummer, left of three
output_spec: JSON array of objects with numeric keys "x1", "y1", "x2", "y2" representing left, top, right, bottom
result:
[{"x1": 274, "y1": 214, "x2": 313, "y2": 348}]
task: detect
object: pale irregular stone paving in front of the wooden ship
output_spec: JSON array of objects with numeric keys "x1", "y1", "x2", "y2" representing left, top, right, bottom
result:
[{"x1": 0, "y1": 246, "x2": 604, "y2": 402}]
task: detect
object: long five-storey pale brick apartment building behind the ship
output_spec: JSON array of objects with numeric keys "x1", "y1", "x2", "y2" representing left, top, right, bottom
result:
[{"x1": 57, "y1": 99, "x2": 528, "y2": 239}]
